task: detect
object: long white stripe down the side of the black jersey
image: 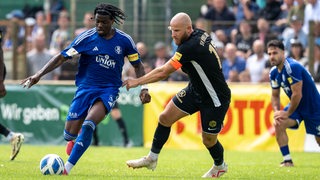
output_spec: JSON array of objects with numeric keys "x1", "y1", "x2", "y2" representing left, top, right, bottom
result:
[{"x1": 191, "y1": 61, "x2": 221, "y2": 107}]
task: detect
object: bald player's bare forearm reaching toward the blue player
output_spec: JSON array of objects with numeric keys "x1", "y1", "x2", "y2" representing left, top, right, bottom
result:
[{"x1": 123, "y1": 61, "x2": 176, "y2": 90}]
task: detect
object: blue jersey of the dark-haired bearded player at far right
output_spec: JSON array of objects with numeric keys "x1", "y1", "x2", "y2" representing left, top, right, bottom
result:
[{"x1": 270, "y1": 58, "x2": 320, "y2": 117}]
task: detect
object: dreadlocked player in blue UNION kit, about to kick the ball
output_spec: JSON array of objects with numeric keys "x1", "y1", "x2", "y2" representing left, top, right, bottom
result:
[{"x1": 21, "y1": 3, "x2": 151, "y2": 175}]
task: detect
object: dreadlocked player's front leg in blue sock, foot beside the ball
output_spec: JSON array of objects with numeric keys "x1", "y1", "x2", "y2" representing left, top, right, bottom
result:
[{"x1": 64, "y1": 100, "x2": 107, "y2": 174}]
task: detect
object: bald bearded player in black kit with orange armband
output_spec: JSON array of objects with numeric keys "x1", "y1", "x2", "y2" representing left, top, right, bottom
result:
[{"x1": 123, "y1": 13, "x2": 231, "y2": 177}]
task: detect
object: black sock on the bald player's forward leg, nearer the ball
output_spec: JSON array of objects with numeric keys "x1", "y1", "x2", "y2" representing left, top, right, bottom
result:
[{"x1": 151, "y1": 123, "x2": 171, "y2": 154}]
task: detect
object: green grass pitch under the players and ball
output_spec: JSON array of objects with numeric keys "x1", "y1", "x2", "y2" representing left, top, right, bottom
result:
[{"x1": 0, "y1": 144, "x2": 320, "y2": 180}]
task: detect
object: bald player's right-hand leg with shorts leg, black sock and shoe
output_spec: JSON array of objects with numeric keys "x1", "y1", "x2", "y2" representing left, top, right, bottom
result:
[{"x1": 200, "y1": 104, "x2": 229, "y2": 177}]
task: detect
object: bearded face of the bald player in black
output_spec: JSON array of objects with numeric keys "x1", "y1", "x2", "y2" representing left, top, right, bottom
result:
[{"x1": 169, "y1": 23, "x2": 189, "y2": 46}]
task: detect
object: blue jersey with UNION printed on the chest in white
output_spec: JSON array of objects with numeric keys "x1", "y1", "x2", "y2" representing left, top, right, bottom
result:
[{"x1": 61, "y1": 28, "x2": 141, "y2": 88}]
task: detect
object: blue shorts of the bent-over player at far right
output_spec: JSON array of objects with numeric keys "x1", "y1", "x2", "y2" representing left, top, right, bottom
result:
[{"x1": 284, "y1": 105, "x2": 320, "y2": 137}]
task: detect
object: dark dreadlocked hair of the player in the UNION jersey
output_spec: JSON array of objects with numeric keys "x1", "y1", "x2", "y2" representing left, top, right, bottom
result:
[{"x1": 94, "y1": 3, "x2": 126, "y2": 24}]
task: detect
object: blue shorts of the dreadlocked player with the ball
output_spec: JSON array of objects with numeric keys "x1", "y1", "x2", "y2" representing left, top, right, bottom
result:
[{"x1": 67, "y1": 87, "x2": 119, "y2": 121}]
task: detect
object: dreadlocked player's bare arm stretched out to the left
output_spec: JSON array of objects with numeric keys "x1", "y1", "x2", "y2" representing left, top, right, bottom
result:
[{"x1": 20, "y1": 54, "x2": 67, "y2": 88}]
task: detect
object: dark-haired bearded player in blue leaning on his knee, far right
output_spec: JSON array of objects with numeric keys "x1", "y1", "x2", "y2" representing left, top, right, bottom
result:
[{"x1": 267, "y1": 40, "x2": 320, "y2": 167}]
